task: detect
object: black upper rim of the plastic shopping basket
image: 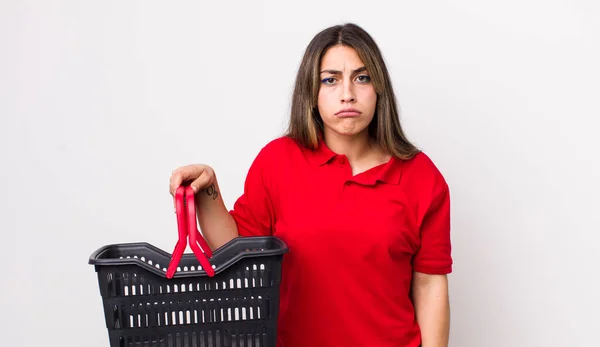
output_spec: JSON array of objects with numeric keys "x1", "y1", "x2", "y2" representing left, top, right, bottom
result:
[{"x1": 88, "y1": 236, "x2": 289, "y2": 278}]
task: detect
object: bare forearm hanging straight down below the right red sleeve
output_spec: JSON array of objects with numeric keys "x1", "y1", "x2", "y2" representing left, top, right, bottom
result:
[{"x1": 413, "y1": 273, "x2": 450, "y2": 347}]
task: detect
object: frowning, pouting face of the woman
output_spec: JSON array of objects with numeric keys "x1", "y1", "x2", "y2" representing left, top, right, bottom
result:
[{"x1": 317, "y1": 45, "x2": 377, "y2": 136}]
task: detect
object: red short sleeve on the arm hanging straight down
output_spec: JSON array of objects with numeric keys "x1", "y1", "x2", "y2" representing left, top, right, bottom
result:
[{"x1": 413, "y1": 180, "x2": 452, "y2": 274}]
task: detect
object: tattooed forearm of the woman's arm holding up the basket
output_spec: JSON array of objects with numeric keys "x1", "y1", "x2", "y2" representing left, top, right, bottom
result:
[{"x1": 196, "y1": 178, "x2": 239, "y2": 250}]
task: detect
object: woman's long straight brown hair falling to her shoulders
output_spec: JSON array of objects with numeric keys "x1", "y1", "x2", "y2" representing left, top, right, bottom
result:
[{"x1": 286, "y1": 23, "x2": 419, "y2": 159}]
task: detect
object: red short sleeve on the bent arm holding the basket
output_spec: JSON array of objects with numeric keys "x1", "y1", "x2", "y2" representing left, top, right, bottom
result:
[{"x1": 229, "y1": 148, "x2": 275, "y2": 236}]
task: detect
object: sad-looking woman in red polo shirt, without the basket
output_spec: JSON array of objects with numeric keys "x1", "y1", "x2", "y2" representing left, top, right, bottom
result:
[{"x1": 170, "y1": 24, "x2": 452, "y2": 347}]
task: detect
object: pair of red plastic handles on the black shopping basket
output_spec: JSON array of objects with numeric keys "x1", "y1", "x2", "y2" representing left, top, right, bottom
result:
[{"x1": 167, "y1": 186, "x2": 215, "y2": 279}]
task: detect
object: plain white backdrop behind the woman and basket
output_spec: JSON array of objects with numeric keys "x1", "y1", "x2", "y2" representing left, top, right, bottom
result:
[{"x1": 0, "y1": 0, "x2": 600, "y2": 347}]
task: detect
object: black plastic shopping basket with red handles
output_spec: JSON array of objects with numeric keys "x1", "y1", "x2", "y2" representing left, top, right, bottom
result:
[{"x1": 89, "y1": 187, "x2": 288, "y2": 347}]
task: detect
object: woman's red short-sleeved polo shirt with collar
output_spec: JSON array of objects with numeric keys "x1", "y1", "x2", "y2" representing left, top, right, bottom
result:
[{"x1": 230, "y1": 137, "x2": 452, "y2": 347}]
